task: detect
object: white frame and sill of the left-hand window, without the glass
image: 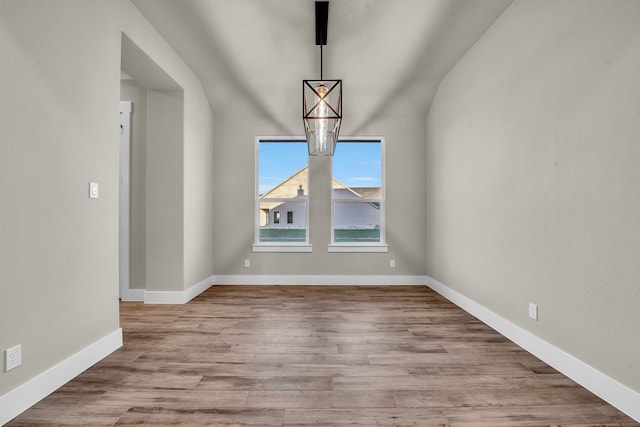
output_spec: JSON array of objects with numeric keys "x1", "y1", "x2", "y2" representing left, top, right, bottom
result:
[{"x1": 251, "y1": 136, "x2": 312, "y2": 252}]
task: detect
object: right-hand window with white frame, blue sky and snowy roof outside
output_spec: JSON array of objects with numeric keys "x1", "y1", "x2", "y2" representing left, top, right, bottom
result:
[{"x1": 329, "y1": 138, "x2": 387, "y2": 252}]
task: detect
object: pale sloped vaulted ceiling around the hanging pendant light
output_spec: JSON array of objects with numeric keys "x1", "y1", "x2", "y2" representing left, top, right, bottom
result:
[{"x1": 133, "y1": 0, "x2": 511, "y2": 135}]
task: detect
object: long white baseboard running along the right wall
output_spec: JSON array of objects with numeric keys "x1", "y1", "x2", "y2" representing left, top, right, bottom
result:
[{"x1": 426, "y1": 276, "x2": 640, "y2": 422}]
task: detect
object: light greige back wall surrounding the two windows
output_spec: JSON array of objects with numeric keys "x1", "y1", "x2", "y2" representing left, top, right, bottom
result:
[{"x1": 213, "y1": 98, "x2": 426, "y2": 275}]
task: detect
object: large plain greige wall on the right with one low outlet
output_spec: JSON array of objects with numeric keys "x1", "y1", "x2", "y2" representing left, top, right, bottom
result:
[{"x1": 426, "y1": 0, "x2": 640, "y2": 391}]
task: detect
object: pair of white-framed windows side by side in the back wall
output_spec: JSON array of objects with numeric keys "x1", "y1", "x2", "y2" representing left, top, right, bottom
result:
[{"x1": 254, "y1": 138, "x2": 387, "y2": 252}]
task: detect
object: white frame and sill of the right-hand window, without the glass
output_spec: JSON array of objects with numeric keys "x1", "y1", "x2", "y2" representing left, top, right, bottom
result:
[{"x1": 328, "y1": 136, "x2": 389, "y2": 252}]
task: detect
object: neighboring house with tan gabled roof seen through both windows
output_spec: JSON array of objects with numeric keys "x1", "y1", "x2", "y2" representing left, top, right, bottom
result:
[{"x1": 260, "y1": 167, "x2": 381, "y2": 229}]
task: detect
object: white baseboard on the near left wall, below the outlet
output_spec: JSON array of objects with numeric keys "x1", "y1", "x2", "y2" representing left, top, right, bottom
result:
[{"x1": 0, "y1": 329, "x2": 122, "y2": 425}]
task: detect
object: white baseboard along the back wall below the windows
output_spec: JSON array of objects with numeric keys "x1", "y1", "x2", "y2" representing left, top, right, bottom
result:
[{"x1": 213, "y1": 275, "x2": 425, "y2": 286}]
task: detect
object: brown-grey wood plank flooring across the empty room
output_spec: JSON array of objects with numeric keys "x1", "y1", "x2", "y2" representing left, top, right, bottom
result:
[{"x1": 8, "y1": 286, "x2": 640, "y2": 427}]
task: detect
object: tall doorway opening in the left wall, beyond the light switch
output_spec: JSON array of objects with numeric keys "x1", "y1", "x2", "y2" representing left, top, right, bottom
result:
[{"x1": 119, "y1": 33, "x2": 184, "y2": 301}]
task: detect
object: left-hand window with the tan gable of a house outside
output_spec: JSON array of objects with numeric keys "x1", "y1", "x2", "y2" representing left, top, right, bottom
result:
[{"x1": 253, "y1": 138, "x2": 311, "y2": 252}]
